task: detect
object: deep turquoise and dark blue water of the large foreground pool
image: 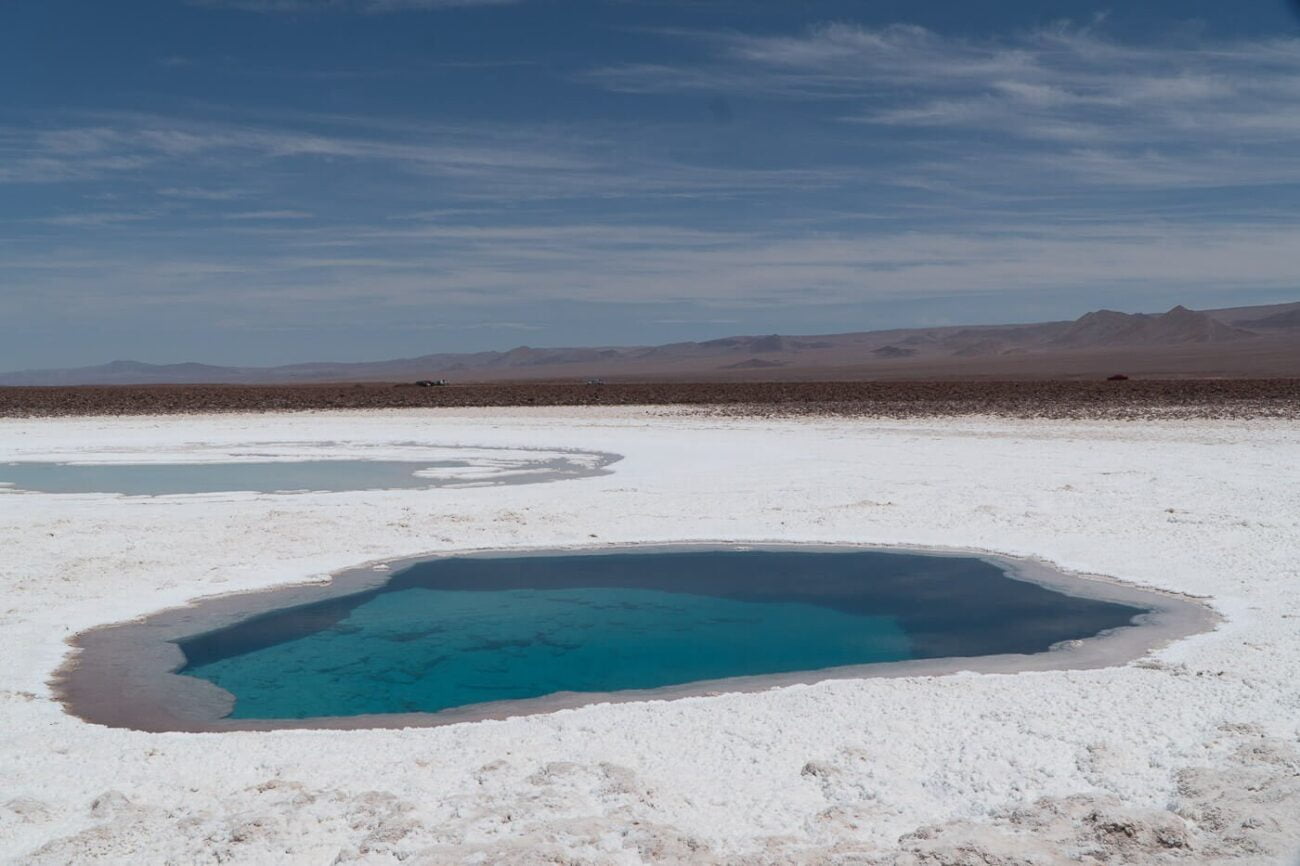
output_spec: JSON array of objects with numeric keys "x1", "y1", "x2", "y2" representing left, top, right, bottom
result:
[{"x1": 181, "y1": 550, "x2": 1144, "y2": 719}]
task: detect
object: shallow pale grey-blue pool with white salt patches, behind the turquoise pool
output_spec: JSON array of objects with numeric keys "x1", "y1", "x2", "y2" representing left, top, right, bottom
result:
[{"x1": 0, "y1": 455, "x2": 613, "y2": 488}]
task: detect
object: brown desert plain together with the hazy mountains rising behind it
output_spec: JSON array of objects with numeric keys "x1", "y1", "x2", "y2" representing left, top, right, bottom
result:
[{"x1": 0, "y1": 303, "x2": 1300, "y2": 417}]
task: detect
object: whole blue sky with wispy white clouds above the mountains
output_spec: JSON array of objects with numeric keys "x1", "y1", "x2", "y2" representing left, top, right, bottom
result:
[{"x1": 0, "y1": 0, "x2": 1300, "y2": 369}]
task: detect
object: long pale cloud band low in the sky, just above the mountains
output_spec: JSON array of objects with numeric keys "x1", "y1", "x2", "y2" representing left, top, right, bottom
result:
[{"x1": 10, "y1": 221, "x2": 1300, "y2": 317}]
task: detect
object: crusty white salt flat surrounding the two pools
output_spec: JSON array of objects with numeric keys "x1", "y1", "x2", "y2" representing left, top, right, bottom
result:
[{"x1": 0, "y1": 408, "x2": 1300, "y2": 863}]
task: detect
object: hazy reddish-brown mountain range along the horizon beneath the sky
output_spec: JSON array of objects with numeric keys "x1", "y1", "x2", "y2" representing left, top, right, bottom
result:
[{"x1": 0, "y1": 303, "x2": 1300, "y2": 385}]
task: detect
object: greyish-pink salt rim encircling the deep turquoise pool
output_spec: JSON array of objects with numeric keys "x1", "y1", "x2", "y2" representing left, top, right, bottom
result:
[{"x1": 49, "y1": 540, "x2": 1222, "y2": 733}]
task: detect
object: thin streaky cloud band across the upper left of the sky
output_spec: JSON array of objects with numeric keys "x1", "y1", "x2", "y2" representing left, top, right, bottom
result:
[{"x1": 0, "y1": 105, "x2": 861, "y2": 209}]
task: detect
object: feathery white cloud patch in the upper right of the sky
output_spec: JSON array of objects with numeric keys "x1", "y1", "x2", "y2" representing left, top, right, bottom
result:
[{"x1": 586, "y1": 23, "x2": 1300, "y2": 187}]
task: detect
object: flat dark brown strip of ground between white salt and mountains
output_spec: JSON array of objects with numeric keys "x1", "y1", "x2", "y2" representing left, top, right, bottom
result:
[{"x1": 0, "y1": 378, "x2": 1300, "y2": 419}]
